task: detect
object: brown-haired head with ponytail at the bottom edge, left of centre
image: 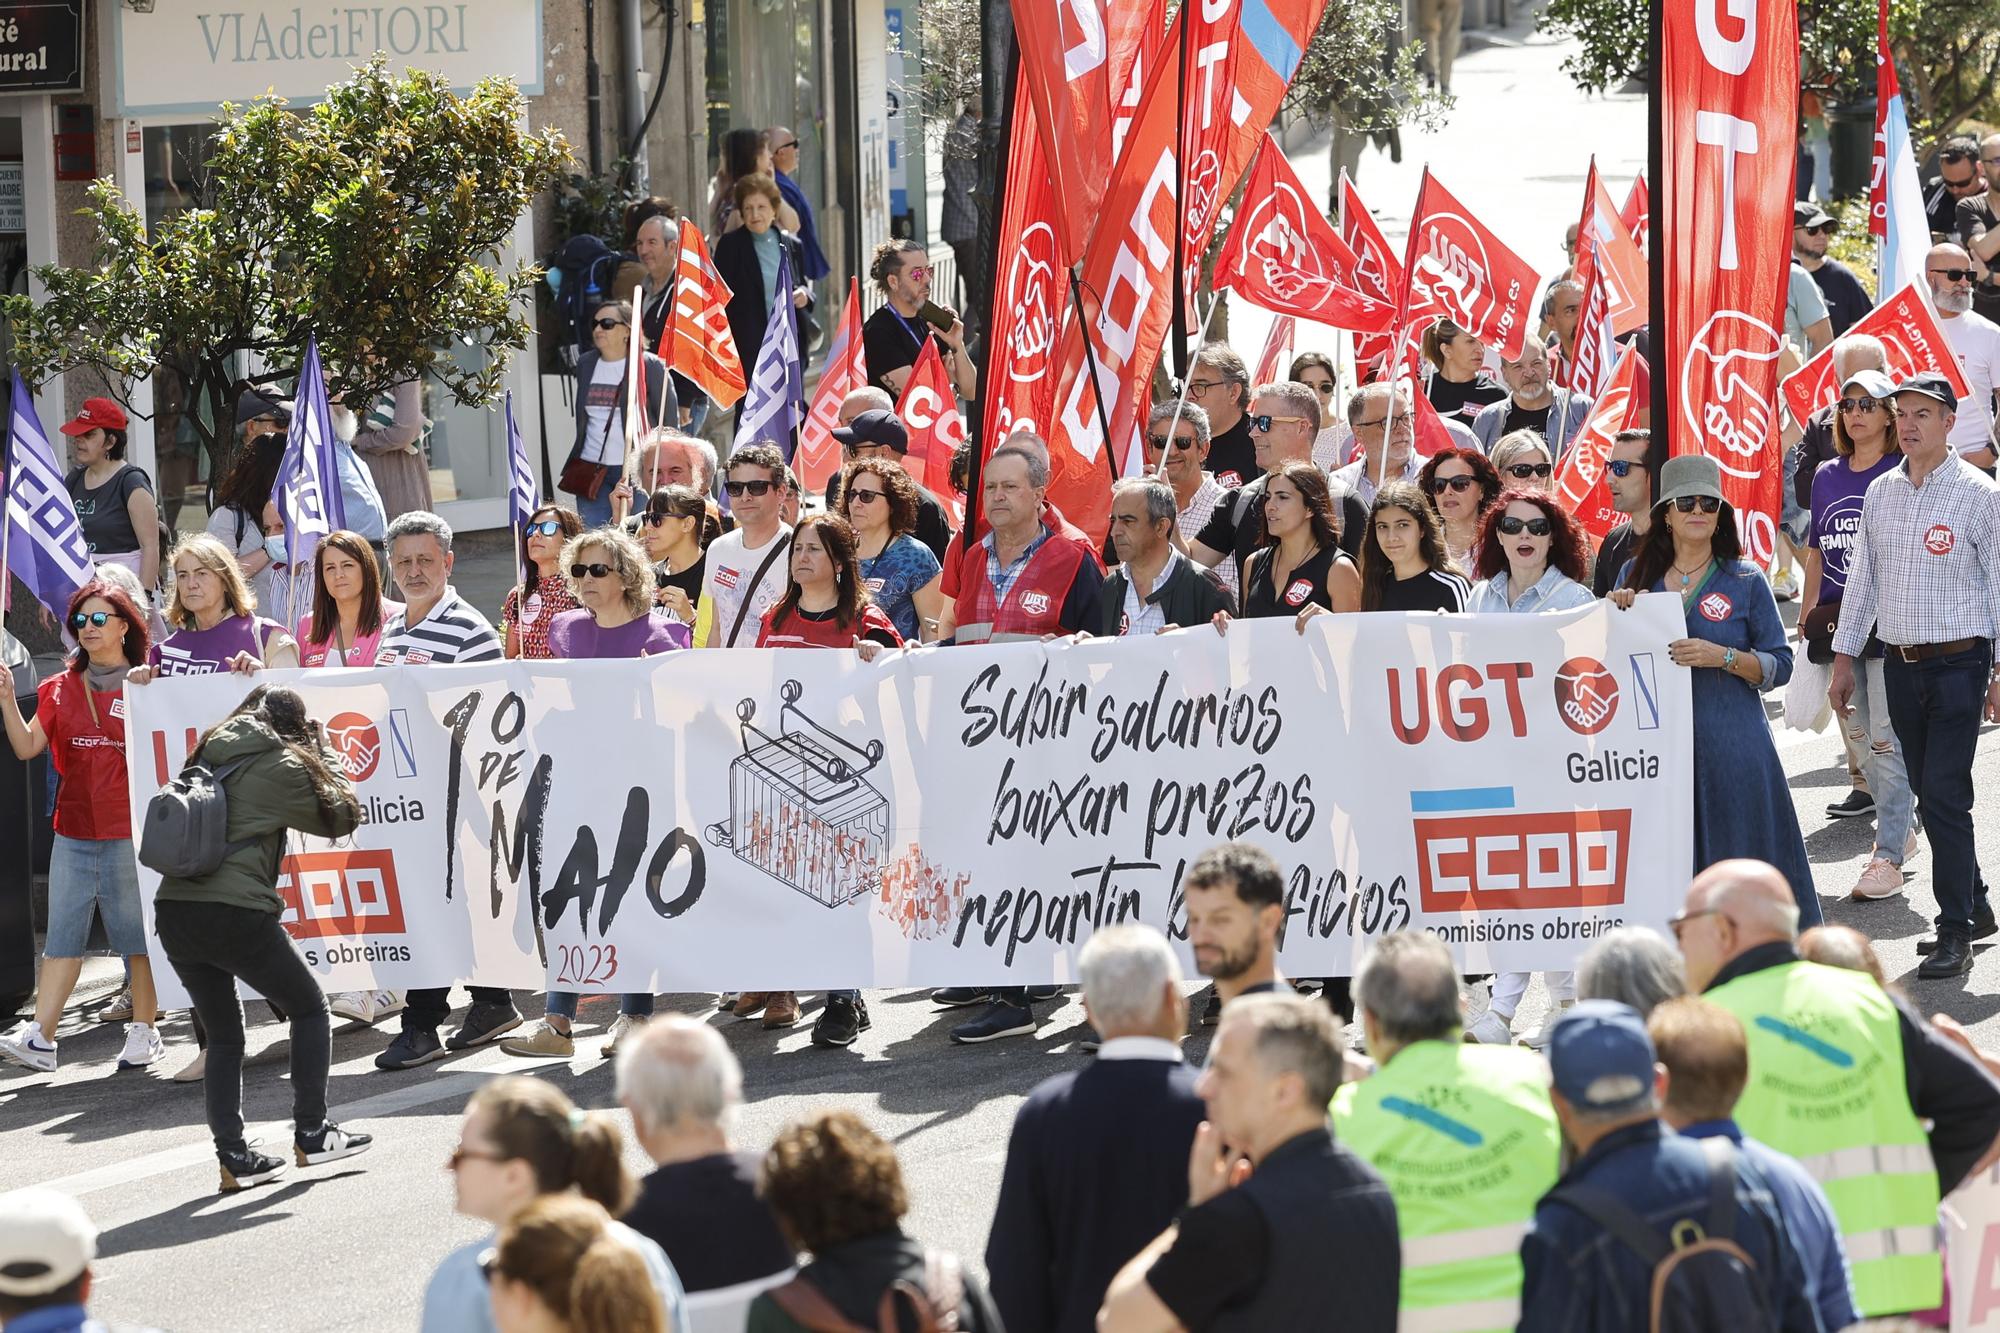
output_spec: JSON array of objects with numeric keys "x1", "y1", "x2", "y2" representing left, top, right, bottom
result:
[{"x1": 480, "y1": 1195, "x2": 672, "y2": 1333}]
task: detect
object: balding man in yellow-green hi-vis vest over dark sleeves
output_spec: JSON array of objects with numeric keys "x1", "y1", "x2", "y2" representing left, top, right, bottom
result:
[{"x1": 1672, "y1": 861, "x2": 2000, "y2": 1319}]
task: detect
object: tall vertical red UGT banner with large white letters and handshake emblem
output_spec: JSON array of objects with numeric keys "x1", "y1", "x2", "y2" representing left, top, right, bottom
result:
[{"x1": 1652, "y1": 0, "x2": 1798, "y2": 564}]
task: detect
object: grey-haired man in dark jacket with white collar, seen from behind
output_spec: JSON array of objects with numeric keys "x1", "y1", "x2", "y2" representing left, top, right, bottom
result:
[{"x1": 986, "y1": 925, "x2": 1202, "y2": 1333}]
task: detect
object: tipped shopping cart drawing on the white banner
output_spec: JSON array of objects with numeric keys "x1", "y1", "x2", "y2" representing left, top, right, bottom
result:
[{"x1": 704, "y1": 681, "x2": 888, "y2": 907}]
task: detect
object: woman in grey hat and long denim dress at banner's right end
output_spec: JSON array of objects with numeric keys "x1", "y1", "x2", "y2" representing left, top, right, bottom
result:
[{"x1": 1610, "y1": 454, "x2": 1830, "y2": 929}]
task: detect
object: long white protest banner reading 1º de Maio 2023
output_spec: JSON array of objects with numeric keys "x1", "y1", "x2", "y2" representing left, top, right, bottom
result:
[{"x1": 132, "y1": 594, "x2": 1694, "y2": 991}]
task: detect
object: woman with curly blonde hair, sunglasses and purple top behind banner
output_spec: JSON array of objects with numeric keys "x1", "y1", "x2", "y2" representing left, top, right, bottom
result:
[{"x1": 500, "y1": 528, "x2": 692, "y2": 1059}]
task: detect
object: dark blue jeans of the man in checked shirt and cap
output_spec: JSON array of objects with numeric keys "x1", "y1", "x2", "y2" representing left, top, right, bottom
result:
[{"x1": 1876, "y1": 642, "x2": 1992, "y2": 931}]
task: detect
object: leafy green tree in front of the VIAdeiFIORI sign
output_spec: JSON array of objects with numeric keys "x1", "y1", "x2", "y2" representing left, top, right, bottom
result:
[{"x1": 4, "y1": 56, "x2": 570, "y2": 474}]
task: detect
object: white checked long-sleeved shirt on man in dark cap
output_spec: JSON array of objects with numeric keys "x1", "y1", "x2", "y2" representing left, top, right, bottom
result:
[{"x1": 1834, "y1": 452, "x2": 2000, "y2": 656}]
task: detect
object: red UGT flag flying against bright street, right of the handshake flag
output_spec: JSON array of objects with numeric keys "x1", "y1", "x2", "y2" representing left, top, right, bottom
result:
[{"x1": 1400, "y1": 168, "x2": 1534, "y2": 360}]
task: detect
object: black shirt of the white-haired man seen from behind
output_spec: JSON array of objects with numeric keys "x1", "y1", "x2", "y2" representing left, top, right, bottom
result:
[{"x1": 624, "y1": 1153, "x2": 794, "y2": 1291}]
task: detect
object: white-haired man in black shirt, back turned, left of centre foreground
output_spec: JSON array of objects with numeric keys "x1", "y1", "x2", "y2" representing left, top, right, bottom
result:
[{"x1": 618, "y1": 1013, "x2": 792, "y2": 1307}]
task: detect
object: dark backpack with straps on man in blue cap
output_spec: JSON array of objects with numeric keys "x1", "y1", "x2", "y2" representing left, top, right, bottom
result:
[{"x1": 1550, "y1": 1139, "x2": 1778, "y2": 1333}]
